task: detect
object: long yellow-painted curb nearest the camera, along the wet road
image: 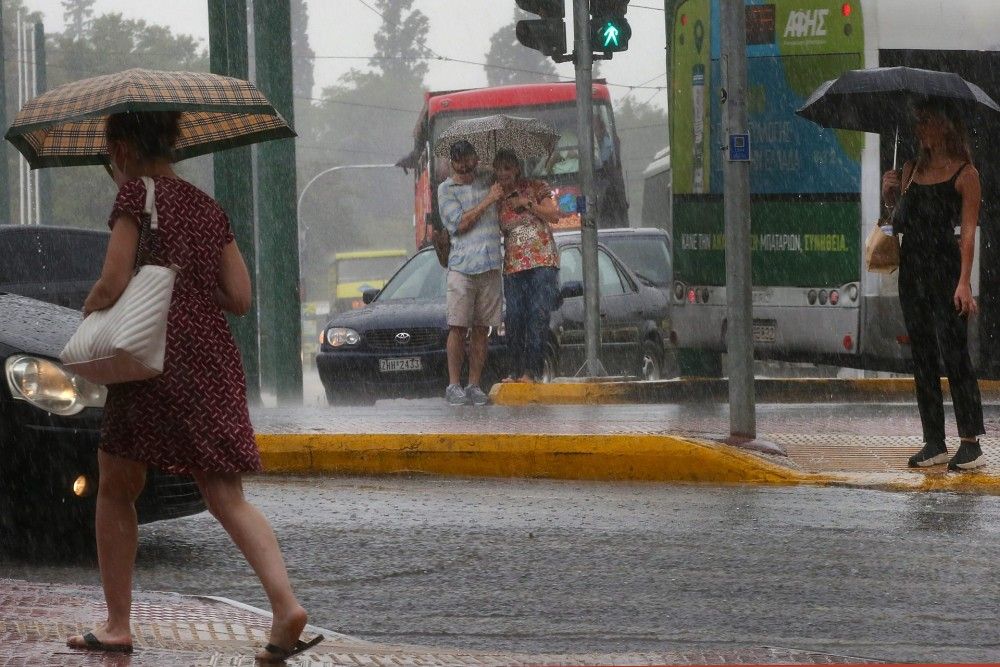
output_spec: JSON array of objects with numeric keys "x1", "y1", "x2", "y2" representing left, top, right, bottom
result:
[{"x1": 257, "y1": 433, "x2": 840, "y2": 485}]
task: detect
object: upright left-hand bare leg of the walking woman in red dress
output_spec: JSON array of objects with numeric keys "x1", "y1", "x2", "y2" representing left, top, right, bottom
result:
[{"x1": 68, "y1": 450, "x2": 146, "y2": 647}]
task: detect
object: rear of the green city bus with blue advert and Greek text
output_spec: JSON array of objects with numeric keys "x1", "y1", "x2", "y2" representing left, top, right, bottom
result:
[{"x1": 670, "y1": 0, "x2": 864, "y2": 366}]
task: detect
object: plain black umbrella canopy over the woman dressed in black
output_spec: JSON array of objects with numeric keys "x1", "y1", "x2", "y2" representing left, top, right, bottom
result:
[{"x1": 795, "y1": 67, "x2": 1000, "y2": 134}]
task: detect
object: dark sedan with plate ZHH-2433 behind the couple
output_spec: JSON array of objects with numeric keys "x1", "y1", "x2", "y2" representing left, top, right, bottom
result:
[{"x1": 316, "y1": 238, "x2": 669, "y2": 403}]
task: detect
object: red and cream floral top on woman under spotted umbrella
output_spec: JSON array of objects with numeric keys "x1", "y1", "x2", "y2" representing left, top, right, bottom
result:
[{"x1": 497, "y1": 180, "x2": 559, "y2": 273}]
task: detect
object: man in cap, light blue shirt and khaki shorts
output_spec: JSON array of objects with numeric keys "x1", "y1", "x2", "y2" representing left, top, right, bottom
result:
[{"x1": 438, "y1": 140, "x2": 503, "y2": 405}]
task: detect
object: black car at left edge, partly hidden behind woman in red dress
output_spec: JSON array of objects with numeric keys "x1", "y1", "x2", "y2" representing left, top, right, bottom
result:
[{"x1": 0, "y1": 226, "x2": 204, "y2": 540}]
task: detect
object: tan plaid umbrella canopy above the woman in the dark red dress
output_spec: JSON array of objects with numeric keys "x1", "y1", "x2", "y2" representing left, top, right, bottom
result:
[{"x1": 5, "y1": 69, "x2": 295, "y2": 169}]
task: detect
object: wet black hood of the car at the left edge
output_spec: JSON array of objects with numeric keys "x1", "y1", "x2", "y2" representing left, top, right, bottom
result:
[{"x1": 0, "y1": 293, "x2": 83, "y2": 359}]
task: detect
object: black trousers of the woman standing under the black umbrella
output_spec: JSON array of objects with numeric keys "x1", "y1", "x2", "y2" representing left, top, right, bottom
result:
[{"x1": 899, "y1": 248, "x2": 986, "y2": 444}]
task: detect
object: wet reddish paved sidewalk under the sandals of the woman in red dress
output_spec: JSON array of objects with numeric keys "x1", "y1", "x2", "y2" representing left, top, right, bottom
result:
[{"x1": 0, "y1": 579, "x2": 877, "y2": 667}]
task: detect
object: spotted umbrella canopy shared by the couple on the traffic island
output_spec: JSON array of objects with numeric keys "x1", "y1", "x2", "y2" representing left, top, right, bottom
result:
[{"x1": 434, "y1": 114, "x2": 559, "y2": 162}]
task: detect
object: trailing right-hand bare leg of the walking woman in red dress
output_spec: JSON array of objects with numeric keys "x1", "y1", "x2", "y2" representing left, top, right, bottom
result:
[{"x1": 194, "y1": 472, "x2": 307, "y2": 657}]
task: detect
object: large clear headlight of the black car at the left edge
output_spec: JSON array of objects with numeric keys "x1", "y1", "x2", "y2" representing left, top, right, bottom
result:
[{"x1": 4, "y1": 355, "x2": 108, "y2": 416}]
